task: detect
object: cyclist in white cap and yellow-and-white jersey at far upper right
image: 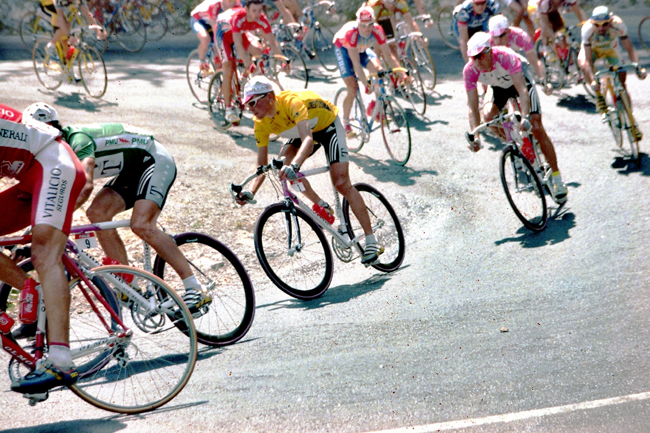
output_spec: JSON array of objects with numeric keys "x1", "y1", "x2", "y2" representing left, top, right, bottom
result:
[{"x1": 578, "y1": 6, "x2": 646, "y2": 135}]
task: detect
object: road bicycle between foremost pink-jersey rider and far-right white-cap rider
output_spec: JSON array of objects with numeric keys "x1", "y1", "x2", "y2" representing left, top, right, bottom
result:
[{"x1": 534, "y1": 24, "x2": 596, "y2": 97}]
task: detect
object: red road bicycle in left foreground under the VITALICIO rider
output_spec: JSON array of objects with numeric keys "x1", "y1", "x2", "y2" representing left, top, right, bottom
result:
[{"x1": 0, "y1": 230, "x2": 197, "y2": 414}]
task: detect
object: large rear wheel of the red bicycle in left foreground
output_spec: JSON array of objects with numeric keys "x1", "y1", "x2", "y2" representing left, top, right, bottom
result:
[{"x1": 70, "y1": 265, "x2": 197, "y2": 414}]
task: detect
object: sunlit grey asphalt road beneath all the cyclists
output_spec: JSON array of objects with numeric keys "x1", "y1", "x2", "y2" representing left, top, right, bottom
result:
[{"x1": 0, "y1": 9, "x2": 650, "y2": 433}]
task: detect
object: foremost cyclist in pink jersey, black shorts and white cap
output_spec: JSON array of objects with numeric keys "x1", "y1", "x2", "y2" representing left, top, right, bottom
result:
[{"x1": 463, "y1": 32, "x2": 567, "y2": 203}]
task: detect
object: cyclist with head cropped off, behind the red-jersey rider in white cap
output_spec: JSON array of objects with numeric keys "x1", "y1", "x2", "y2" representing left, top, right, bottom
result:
[{"x1": 190, "y1": 0, "x2": 241, "y2": 77}]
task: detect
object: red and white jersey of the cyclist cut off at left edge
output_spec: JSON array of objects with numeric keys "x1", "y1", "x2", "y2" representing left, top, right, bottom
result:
[{"x1": 0, "y1": 104, "x2": 61, "y2": 178}]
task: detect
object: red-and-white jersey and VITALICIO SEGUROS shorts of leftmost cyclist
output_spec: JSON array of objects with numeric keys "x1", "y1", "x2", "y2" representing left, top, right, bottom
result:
[{"x1": 0, "y1": 104, "x2": 85, "y2": 235}]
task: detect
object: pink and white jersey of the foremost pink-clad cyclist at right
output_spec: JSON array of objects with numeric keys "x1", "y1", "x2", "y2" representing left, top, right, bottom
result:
[{"x1": 463, "y1": 47, "x2": 522, "y2": 91}]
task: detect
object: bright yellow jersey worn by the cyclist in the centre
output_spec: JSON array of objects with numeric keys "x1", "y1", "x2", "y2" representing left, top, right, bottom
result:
[{"x1": 254, "y1": 90, "x2": 339, "y2": 147}]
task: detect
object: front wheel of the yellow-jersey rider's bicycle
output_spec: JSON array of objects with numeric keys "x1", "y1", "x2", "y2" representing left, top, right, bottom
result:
[{"x1": 255, "y1": 203, "x2": 334, "y2": 300}]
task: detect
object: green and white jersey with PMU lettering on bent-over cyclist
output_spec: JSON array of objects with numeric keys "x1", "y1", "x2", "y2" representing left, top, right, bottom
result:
[{"x1": 63, "y1": 123, "x2": 158, "y2": 179}]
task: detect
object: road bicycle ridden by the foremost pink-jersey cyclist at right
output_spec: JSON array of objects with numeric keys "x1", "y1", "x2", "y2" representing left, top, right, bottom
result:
[{"x1": 466, "y1": 103, "x2": 566, "y2": 232}]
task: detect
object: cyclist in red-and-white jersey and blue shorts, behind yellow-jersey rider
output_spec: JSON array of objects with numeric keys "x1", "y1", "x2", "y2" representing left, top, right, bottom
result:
[{"x1": 334, "y1": 6, "x2": 399, "y2": 137}]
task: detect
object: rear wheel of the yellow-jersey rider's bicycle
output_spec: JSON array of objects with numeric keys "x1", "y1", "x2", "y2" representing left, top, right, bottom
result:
[{"x1": 342, "y1": 183, "x2": 406, "y2": 272}]
